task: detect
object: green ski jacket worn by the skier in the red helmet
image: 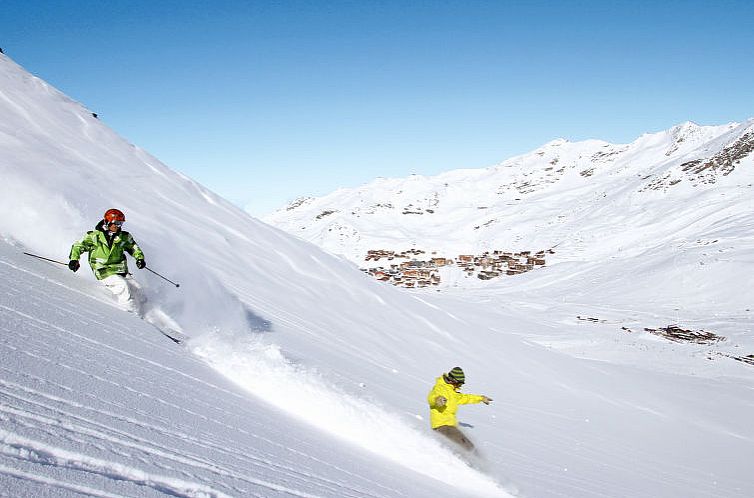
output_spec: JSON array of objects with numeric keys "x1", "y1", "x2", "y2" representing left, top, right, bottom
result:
[{"x1": 69, "y1": 221, "x2": 144, "y2": 280}]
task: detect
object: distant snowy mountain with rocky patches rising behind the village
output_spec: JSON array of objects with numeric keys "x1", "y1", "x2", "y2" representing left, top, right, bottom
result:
[{"x1": 266, "y1": 120, "x2": 754, "y2": 287}]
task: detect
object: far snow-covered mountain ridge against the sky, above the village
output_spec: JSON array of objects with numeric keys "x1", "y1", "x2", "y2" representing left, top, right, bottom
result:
[{"x1": 264, "y1": 119, "x2": 754, "y2": 284}]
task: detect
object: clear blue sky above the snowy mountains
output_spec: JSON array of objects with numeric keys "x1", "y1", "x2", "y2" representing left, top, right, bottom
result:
[{"x1": 5, "y1": 0, "x2": 754, "y2": 214}]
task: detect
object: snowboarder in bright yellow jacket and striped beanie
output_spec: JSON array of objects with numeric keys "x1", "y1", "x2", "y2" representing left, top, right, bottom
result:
[{"x1": 427, "y1": 367, "x2": 492, "y2": 451}]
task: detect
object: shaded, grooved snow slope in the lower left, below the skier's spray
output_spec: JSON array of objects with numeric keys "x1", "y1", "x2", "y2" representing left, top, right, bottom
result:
[{"x1": 0, "y1": 243, "x2": 470, "y2": 498}]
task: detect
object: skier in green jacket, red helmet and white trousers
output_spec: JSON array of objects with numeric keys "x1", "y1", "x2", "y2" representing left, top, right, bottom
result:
[{"x1": 68, "y1": 209, "x2": 146, "y2": 312}]
